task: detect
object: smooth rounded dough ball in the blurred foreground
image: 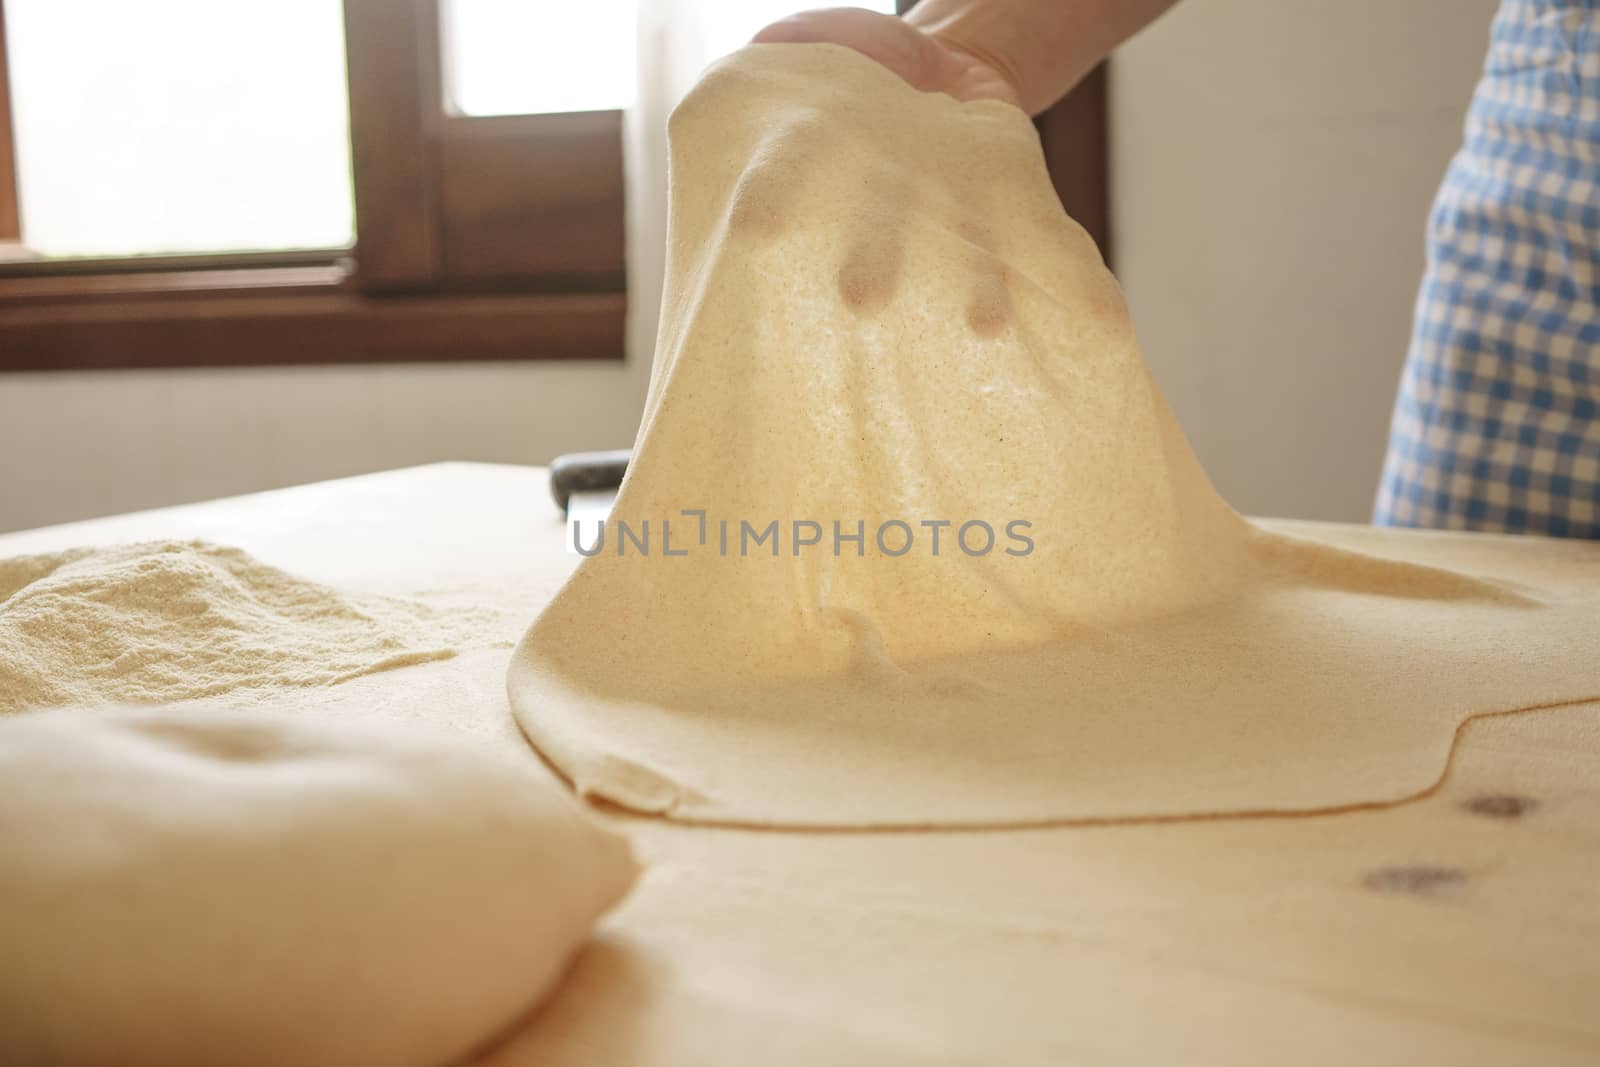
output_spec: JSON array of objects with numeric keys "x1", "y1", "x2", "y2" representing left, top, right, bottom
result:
[{"x1": 0, "y1": 709, "x2": 637, "y2": 1067}]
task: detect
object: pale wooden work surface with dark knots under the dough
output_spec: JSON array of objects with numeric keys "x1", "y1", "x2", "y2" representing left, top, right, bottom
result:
[{"x1": 0, "y1": 464, "x2": 1600, "y2": 1067}]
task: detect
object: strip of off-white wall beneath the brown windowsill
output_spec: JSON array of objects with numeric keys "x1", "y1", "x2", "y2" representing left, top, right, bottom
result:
[{"x1": 0, "y1": 362, "x2": 645, "y2": 531}]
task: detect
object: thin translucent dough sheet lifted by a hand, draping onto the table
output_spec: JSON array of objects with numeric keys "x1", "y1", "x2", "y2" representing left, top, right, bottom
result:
[{"x1": 509, "y1": 45, "x2": 1600, "y2": 827}]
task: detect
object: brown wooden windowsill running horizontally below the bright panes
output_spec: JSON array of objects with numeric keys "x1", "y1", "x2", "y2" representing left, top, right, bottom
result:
[{"x1": 0, "y1": 253, "x2": 626, "y2": 373}]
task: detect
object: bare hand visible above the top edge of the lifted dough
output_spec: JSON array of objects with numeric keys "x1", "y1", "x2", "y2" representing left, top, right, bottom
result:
[{"x1": 752, "y1": 8, "x2": 1021, "y2": 107}]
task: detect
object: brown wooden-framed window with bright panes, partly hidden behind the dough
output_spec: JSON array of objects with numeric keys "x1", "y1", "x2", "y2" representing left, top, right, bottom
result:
[{"x1": 0, "y1": 0, "x2": 1106, "y2": 371}]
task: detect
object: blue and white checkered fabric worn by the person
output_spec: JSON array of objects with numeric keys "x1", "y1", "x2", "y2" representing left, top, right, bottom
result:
[{"x1": 1374, "y1": 0, "x2": 1600, "y2": 537}]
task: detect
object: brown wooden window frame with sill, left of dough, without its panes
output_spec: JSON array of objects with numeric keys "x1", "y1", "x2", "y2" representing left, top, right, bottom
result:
[{"x1": 0, "y1": 0, "x2": 626, "y2": 373}]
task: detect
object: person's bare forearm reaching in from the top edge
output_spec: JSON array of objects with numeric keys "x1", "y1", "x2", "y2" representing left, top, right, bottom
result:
[{"x1": 906, "y1": 0, "x2": 1176, "y2": 114}]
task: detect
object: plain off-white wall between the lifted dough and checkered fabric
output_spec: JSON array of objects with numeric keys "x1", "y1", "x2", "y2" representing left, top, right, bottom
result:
[{"x1": 1112, "y1": 0, "x2": 1496, "y2": 522}]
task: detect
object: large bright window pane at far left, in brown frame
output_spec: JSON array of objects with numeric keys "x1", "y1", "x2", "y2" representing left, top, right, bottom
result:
[{"x1": 3, "y1": 0, "x2": 354, "y2": 256}]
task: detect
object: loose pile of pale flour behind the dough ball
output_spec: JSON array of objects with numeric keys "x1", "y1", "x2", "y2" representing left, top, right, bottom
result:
[{"x1": 0, "y1": 541, "x2": 472, "y2": 713}]
